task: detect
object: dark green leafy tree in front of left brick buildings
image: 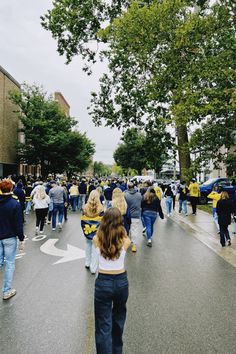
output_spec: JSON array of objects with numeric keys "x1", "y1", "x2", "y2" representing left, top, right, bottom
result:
[{"x1": 10, "y1": 84, "x2": 94, "y2": 177}]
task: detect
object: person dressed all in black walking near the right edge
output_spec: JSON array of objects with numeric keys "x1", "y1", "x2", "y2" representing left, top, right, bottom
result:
[{"x1": 216, "y1": 191, "x2": 233, "y2": 247}]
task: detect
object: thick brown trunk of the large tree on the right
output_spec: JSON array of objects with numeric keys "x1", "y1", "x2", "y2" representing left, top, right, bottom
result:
[{"x1": 176, "y1": 125, "x2": 192, "y2": 181}]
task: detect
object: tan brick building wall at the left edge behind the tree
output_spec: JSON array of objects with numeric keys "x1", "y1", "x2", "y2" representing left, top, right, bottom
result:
[{"x1": 0, "y1": 66, "x2": 20, "y2": 176}]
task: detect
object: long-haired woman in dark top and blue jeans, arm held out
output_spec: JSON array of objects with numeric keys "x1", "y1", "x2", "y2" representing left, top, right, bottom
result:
[{"x1": 141, "y1": 187, "x2": 164, "y2": 247}]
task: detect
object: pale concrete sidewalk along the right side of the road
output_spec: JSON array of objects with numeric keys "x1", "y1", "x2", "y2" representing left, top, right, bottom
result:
[{"x1": 163, "y1": 202, "x2": 236, "y2": 268}]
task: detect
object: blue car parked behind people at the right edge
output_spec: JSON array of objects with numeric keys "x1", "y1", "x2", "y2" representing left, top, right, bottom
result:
[{"x1": 200, "y1": 178, "x2": 236, "y2": 204}]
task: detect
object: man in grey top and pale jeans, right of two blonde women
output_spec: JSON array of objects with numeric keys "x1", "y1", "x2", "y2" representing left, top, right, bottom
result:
[{"x1": 125, "y1": 182, "x2": 142, "y2": 252}]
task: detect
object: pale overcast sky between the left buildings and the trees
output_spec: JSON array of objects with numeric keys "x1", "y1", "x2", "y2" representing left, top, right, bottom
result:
[{"x1": 0, "y1": 0, "x2": 120, "y2": 163}]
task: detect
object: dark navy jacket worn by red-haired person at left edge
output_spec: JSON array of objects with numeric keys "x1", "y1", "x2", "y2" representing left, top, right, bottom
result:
[{"x1": 0, "y1": 194, "x2": 24, "y2": 241}]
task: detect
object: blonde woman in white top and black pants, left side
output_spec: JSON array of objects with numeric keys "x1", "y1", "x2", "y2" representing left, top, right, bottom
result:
[{"x1": 33, "y1": 186, "x2": 50, "y2": 235}]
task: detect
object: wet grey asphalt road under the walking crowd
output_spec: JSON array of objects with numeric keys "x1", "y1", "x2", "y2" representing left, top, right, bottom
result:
[{"x1": 0, "y1": 207, "x2": 236, "y2": 354}]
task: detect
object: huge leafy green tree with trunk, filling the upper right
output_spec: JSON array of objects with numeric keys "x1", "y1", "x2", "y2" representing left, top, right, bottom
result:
[{"x1": 42, "y1": 0, "x2": 236, "y2": 178}]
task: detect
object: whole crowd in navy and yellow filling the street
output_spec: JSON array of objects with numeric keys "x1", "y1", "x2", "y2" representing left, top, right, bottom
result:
[{"x1": 0, "y1": 177, "x2": 236, "y2": 353}]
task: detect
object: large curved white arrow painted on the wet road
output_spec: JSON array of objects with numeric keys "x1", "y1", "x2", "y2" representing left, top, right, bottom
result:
[{"x1": 40, "y1": 239, "x2": 85, "y2": 264}]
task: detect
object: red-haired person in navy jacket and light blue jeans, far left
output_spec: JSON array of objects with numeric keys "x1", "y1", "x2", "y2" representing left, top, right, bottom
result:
[{"x1": 0, "y1": 179, "x2": 24, "y2": 300}]
